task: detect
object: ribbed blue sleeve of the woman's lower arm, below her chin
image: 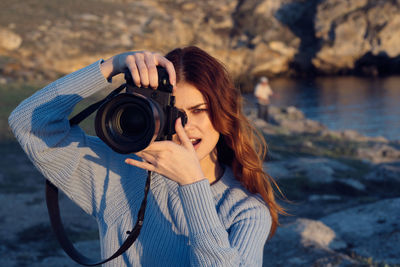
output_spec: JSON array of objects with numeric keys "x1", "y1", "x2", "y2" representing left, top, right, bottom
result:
[{"x1": 179, "y1": 180, "x2": 271, "y2": 266}]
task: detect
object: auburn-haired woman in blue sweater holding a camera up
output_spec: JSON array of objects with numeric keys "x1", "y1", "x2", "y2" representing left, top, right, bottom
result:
[{"x1": 9, "y1": 47, "x2": 282, "y2": 266}]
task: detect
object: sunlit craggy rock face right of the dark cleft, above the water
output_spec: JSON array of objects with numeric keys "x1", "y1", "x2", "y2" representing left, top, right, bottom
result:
[{"x1": 312, "y1": 0, "x2": 400, "y2": 75}]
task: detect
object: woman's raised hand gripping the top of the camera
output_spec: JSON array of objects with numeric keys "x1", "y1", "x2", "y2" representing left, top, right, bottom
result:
[{"x1": 100, "y1": 51, "x2": 176, "y2": 88}]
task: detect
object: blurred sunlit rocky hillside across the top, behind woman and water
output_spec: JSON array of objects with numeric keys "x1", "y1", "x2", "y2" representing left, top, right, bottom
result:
[{"x1": 0, "y1": 0, "x2": 400, "y2": 89}]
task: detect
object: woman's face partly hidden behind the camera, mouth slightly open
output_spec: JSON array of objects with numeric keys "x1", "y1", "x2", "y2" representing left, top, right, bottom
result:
[{"x1": 174, "y1": 82, "x2": 219, "y2": 166}]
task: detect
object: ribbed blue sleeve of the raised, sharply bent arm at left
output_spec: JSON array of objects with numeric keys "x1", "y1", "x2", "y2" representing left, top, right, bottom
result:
[{"x1": 9, "y1": 62, "x2": 142, "y2": 222}]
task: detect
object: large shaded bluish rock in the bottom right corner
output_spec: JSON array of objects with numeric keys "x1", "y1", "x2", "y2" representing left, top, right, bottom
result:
[{"x1": 321, "y1": 198, "x2": 400, "y2": 264}]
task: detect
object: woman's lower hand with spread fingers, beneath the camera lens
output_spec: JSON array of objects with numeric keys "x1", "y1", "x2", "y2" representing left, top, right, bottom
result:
[{"x1": 125, "y1": 118, "x2": 205, "y2": 185}]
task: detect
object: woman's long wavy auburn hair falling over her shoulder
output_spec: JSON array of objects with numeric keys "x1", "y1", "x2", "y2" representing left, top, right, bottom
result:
[{"x1": 166, "y1": 46, "x2": 285, "y2": 237}]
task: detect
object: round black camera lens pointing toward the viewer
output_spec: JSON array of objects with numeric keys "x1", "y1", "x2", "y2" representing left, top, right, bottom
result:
[{"x1": 95, "y1": 93, "x2": 164, "y2": 154}]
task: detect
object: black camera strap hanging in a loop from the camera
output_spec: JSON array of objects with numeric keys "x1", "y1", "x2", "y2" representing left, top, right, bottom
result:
[{"x1": 46, "y1": 84, "x2": 151, "y2": 266}]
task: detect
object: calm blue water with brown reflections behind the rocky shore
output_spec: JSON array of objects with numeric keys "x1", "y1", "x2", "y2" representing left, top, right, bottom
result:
[{"x1": 264, "y1": 76, "x2": 400, "y2": 140}]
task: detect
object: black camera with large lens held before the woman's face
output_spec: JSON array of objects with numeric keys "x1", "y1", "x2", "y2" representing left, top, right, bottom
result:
[{"x1": 95, "y1": 67, "x2": 187, "y2": 154}]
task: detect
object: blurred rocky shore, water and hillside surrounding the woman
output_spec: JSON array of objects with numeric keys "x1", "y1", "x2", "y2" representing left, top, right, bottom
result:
[{"x1": 0, "y1": 0, "x2": 400, "y2": 266}]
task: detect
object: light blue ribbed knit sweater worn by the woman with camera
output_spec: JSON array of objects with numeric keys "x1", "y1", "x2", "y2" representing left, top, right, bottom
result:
[{"x1": 9, "y1": 61, "x2": 271, "y2": 266}]
